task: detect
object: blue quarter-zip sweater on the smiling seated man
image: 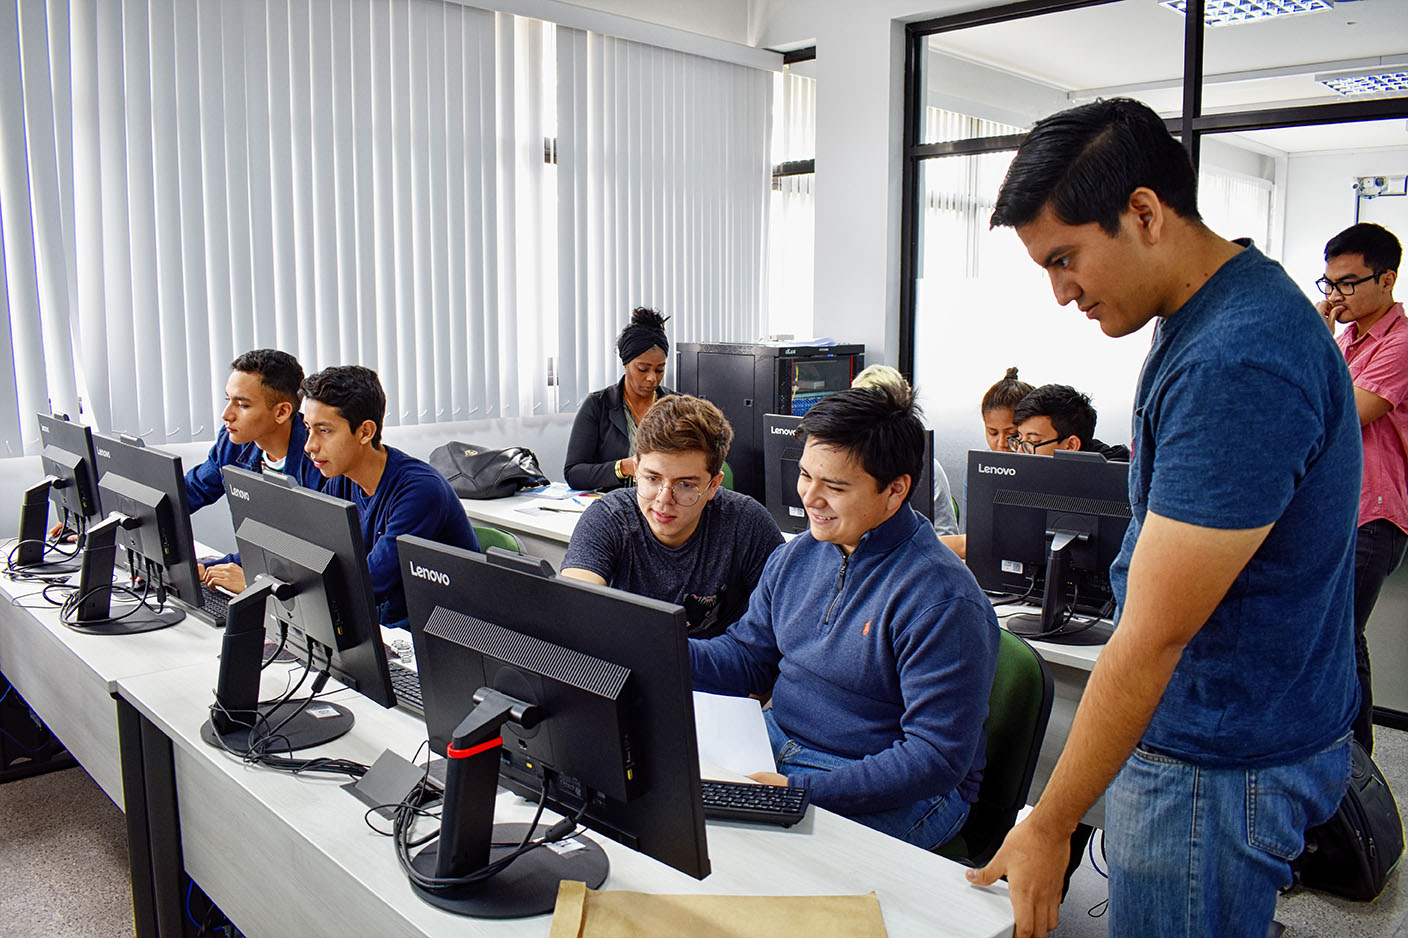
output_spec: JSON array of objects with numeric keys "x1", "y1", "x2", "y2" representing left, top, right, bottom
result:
[{"x1": 690, "y1": 506, "x2": 997, "y2": 814}]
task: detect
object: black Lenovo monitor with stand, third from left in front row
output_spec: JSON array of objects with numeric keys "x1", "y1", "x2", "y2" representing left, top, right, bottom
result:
[{"x1": 201, "y1": 466, "x2": 396, "y2": 753}]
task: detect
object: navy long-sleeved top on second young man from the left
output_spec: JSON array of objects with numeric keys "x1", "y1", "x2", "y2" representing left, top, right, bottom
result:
[{"x1": 322, "y1": 446, "x2": 479, "y2": 625}]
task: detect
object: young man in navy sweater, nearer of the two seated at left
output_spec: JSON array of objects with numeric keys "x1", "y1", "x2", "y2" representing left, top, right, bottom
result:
[{"x1": 303, "y1": 365, "x2": 479, "y2": 628}]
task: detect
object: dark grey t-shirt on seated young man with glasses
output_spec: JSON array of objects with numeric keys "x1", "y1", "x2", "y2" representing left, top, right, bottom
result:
[{"x1": 562, "y1": 487, "x2": 783, "y2": 638}]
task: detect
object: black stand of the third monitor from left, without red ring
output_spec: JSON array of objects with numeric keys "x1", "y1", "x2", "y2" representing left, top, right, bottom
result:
[{"x1": 200, "y1": 573, "x2": 355, "y2": 755}]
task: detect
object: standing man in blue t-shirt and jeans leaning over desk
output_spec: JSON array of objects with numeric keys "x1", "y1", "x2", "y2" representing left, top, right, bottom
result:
[{"x1": 969, "y1": 99, "x2": 1360, "y2": 938}]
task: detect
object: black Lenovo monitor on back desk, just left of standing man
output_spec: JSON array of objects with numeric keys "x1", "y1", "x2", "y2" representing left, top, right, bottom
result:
[{"x1": 967, "y1": 449, "x2": 1131, "y2": 645}]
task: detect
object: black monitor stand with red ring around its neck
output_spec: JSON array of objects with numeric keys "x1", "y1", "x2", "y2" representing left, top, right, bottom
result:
[{"x1": 411, "y1": 687, "x2": 611, "y2": 918}]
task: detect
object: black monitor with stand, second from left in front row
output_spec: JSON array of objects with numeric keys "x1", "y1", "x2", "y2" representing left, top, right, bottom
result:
[{"x1": 65, "y1": 434, "x2": 201, "y2": 635}]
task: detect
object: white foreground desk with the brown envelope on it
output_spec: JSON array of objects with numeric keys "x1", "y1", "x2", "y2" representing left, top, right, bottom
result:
[{"x1": 118, "y1": 663, "x2": 1012, "y2": 938}]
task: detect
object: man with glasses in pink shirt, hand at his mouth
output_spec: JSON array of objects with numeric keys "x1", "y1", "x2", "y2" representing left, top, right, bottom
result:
[{"x1": 1315, "y1": 224, "x2": 1408, "y2": 752}]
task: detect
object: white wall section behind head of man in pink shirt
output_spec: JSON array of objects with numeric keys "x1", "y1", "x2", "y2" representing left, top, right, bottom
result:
[{"x1": 1283, "y1": 146, "x2": 1408, "y2": 300}]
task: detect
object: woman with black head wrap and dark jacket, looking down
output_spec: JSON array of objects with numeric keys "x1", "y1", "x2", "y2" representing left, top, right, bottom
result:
[{"x1": 563, "y1": 307, "x2": 674, "y2": 489}]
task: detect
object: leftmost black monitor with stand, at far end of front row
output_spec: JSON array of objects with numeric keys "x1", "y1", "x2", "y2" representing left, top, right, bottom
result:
[{"x1": 14, "y1": 414, "x2": 100, "y2": 573}]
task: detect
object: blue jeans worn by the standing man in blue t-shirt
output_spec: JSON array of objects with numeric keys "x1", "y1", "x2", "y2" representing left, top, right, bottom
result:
[{"x1": 1105, "y1": 734, "x2": 1349, "y2": 938}]
